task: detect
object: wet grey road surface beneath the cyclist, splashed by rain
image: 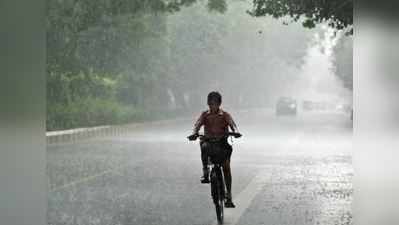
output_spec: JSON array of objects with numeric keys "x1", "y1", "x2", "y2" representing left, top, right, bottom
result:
[{"x1": 47, "y1": 108, "x2": 353, "y2": 225}]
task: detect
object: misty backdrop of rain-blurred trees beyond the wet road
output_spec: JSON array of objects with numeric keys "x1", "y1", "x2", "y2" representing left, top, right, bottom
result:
[{"x1": 46, "y1": 0, "x2": 353, "y2": 130}]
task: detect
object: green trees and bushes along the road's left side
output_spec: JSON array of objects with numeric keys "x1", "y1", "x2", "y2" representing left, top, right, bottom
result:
[{"x1": 46, "y1": 0, "x2": 234, "y2": 130}]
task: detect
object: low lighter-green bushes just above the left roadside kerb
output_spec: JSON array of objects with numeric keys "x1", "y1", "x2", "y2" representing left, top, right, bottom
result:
[{"x1": 47, "y1": 73, "x2": 180, "y2": 130}]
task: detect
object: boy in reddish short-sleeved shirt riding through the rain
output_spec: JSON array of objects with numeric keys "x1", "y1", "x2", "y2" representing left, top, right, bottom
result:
[{"x1": 189, "y1": 91, "x2": 238, "y2": 208}]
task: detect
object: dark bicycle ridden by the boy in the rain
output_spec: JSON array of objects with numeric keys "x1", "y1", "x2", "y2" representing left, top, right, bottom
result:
[{"x1": 187, "y1": 132, "x2": 241, "y2": 224}]
